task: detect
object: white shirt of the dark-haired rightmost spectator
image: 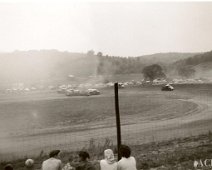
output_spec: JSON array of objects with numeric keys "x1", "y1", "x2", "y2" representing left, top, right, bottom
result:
[{"x1": 118, "y1": 156, "x2": 137, "y2": 170}]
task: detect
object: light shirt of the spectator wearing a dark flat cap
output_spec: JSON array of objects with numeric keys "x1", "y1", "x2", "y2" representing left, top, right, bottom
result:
[{"x1": 42, "y1": 158, "x2": 62, "y2": 170}]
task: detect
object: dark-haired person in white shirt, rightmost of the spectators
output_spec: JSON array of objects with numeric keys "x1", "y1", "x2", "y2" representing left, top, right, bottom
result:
[{"x1": 117, "y1": 145, "x2": 137, "y2": 170}]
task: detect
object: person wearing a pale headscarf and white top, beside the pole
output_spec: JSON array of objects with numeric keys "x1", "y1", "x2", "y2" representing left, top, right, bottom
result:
[{"x1": 100, "y1": 149, "x2": 117, "y2": 170}]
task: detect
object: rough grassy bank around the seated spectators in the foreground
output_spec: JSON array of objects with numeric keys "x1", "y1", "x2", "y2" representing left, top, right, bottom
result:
[{"x1": 0, "y1": 131, "x2": 212, "y2": 170}]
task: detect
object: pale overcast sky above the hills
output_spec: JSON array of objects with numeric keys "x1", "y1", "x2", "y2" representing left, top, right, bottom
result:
[{"x1": 0, "y1": 0, "x2": 212, "y2": 56}]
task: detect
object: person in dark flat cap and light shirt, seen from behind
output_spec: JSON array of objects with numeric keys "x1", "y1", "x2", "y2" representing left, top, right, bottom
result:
[{"x1": 42, "y1": 150, "x2": 62, "y2": 170}]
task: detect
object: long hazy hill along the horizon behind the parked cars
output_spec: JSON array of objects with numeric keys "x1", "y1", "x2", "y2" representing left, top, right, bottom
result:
[{"x1": 0, "y1": 50, "x2": 207, "y2": 84}]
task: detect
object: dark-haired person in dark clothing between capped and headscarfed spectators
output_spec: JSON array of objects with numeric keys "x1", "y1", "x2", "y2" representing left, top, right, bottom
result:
[{"x1": 70, "y1": 151, "x2": 96, "y2": 170}]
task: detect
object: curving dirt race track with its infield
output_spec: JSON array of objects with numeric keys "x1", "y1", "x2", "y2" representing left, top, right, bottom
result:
[{"x1": 0, "y1": 85, "x2": 212, "y2": 159}]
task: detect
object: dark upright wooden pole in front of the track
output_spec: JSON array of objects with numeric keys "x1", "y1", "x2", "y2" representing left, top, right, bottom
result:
[{"x1": 114, "y1": 83, "x2": 121, "y2": 160}]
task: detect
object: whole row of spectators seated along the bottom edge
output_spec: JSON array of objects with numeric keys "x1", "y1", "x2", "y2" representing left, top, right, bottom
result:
[{"x1": 4, "y1": 145, "x2": 137, "y2": 170}]
